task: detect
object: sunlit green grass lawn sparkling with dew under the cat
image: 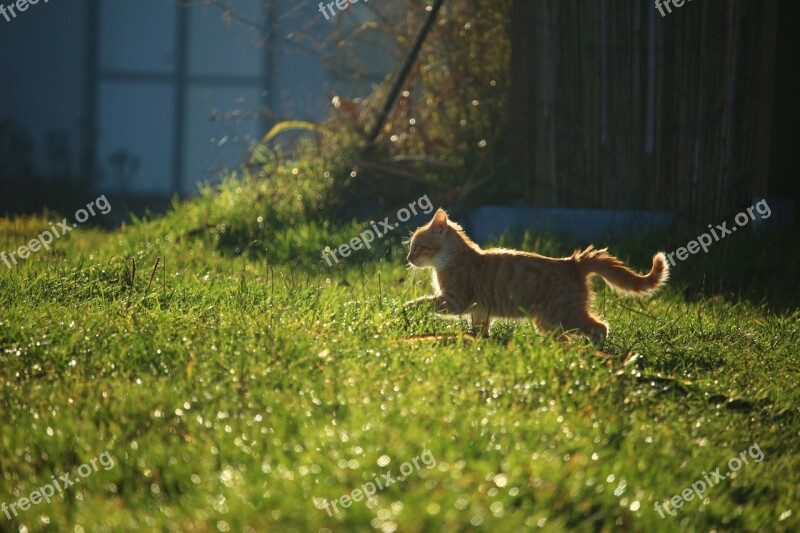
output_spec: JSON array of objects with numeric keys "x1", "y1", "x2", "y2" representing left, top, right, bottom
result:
[{"x1": 0, "y1": 181, "x2": 800, "y2": 532}]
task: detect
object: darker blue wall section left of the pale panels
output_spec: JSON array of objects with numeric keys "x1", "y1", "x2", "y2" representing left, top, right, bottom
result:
[{"x1": 0, "y1": 0, "x2": 88, "y2": 187}]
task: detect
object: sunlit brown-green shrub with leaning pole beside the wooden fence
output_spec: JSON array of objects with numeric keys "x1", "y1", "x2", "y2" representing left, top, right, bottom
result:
[{"x1": 241, "y1": 0, "x2": 511, "y2": 212}]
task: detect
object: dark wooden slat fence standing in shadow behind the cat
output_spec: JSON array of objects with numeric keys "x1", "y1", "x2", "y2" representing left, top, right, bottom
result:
[{"x1": 508, "y1": 0, "x2": 777, "y2": 219}]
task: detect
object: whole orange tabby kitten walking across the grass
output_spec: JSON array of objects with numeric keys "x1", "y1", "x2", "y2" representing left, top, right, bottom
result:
[{"x1": 405, "y1": 209, "x2": 669, "y2": 342}]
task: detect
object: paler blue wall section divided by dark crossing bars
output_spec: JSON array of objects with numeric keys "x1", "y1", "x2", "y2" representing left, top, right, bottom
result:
[{"x1": 95, "y1": 0, "x2": 276, "y2": 195}]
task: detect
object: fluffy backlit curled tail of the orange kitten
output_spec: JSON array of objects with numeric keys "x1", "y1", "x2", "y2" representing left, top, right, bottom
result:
[{"x1": 572, "y1": 246, "x2": 669, "y2": 296}]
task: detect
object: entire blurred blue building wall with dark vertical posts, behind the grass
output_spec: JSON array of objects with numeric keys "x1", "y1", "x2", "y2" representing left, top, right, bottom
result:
[{"x1": 0, "y1": 0, "x2": 362, "y2": 202}]
